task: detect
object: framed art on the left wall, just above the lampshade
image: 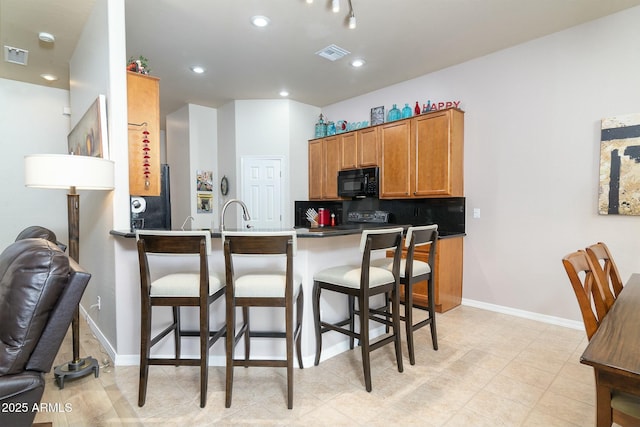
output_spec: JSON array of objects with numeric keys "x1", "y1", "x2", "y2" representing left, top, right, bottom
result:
[{"x1": 67, "y1": 95, "x2": 109, "y2": 159}]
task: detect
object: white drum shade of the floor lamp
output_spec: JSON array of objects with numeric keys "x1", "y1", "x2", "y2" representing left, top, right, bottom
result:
[{"x1": 24, "y1": 154, "x2": 114, "y2": 190}]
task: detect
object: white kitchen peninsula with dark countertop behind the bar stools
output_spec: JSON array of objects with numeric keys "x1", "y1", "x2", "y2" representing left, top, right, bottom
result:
[{"x1": 111, "y1": 224, "x2": 464, "y2": 367}]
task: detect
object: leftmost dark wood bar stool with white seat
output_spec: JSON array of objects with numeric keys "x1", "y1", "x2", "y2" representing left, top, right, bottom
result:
[{"x1": 136, "y1": 230, "x2": 225, "y2": 408}]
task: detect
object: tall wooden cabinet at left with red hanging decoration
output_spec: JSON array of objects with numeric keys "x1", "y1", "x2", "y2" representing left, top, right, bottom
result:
[{"x1": 127, "y1": 71, "x2": 160, "y2": 196}]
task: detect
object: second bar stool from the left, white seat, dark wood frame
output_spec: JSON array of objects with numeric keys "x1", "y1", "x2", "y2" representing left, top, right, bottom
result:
[{"x1": 222, "y1": 231, "x2": 303, "y2": 409}]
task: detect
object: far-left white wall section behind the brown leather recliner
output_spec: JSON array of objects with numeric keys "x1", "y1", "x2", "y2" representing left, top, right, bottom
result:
[{"x1": 0, "y1": 79, "x2": 70, "y2": 249}]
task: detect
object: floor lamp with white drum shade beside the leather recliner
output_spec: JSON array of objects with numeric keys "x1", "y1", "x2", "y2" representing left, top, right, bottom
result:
[{"x1": 24, "y1": 154, "x2": 114, "y2": 388}]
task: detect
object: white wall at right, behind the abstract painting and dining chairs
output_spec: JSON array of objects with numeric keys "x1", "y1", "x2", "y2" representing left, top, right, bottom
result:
[{"x1": 323, "y1": 7, "x2": 640, "y2": 320}]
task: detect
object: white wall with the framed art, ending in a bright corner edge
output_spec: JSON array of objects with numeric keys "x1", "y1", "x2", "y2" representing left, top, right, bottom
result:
[{"x1": 69, "y1": 0, "x2": 131, "y2": 350}]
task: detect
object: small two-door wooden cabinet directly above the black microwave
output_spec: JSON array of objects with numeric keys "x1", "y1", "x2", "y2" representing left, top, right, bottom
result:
[{"x1": 339, "y1": 127, "x2": 379, "y2": 170}]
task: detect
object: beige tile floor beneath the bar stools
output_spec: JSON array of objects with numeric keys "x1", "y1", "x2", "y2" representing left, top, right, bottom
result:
[{"x1": 36, "y1": 306, "x2": 608, "y2": 427}]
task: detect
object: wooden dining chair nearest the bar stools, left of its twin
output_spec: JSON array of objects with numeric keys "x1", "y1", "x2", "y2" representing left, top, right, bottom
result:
[{"x1": 562, "y1": 250, "x2": 640, "y2": 426}]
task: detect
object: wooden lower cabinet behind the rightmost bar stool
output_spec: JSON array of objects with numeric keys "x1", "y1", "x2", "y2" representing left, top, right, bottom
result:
[{"x1": 387, "y1": 236, "x2": 463, "y2": 313}]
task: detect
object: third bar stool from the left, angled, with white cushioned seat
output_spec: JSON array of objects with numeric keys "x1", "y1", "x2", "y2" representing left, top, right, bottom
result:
[{"x1": 312, "y1": 228, "x2": 403, "y2": 392}]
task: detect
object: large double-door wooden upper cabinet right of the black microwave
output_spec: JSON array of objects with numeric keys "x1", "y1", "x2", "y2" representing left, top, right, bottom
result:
[{"x1": 380, "y1": 108, "x2": 464, "y2": 199}]
